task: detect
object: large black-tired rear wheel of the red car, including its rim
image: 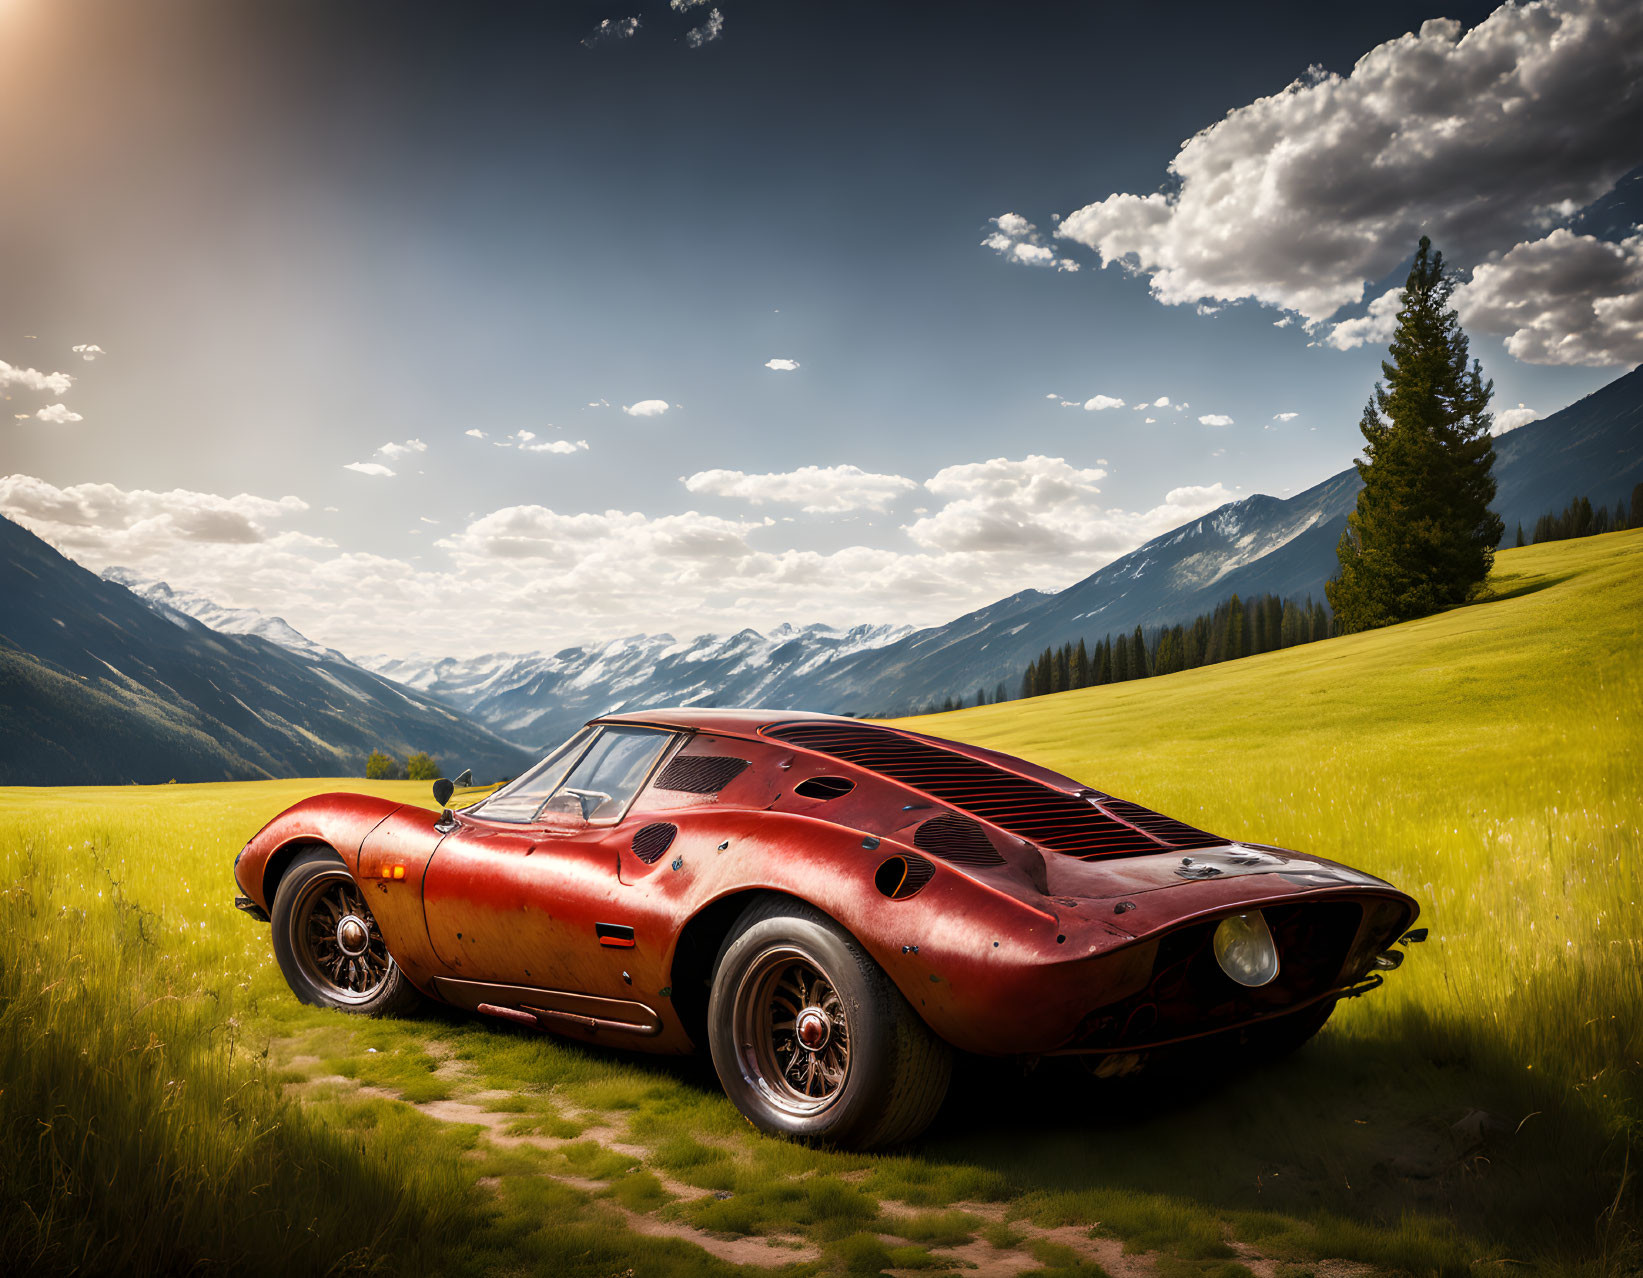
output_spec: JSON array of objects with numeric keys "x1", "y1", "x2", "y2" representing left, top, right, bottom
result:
[{"x1": 708, "y1": 897, "x2": 953, "y2": 1150}]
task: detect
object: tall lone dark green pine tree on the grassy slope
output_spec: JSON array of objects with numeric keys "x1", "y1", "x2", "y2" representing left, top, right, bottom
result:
[{"x1": 1328, "y1": 235, "x2": 1505, "y2": 631}]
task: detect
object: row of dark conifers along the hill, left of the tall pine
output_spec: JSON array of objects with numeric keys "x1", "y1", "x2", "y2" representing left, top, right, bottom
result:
[{"x1": 997, "y1": 595, "x2": 1334, "y2": 700}]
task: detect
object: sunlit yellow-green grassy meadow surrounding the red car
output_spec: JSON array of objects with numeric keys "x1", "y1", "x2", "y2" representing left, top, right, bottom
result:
[{"x1": 0, "y1": 531, "x2": 1643, "y2": 1278}]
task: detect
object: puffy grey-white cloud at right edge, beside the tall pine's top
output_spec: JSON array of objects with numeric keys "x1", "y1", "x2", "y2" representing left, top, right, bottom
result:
[{"x1": 1454, "y1": 228, "x2": 1643, "y2": 366}]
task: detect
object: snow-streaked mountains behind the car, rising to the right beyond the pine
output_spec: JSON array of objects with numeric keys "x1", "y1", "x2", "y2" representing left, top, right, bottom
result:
[{"x1": 365, "y1": 358, "x2": 1643, "y2": 746}]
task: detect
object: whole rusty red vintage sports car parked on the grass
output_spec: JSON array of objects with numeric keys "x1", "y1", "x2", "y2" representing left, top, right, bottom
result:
[{"x1": 235, "y1": 710, "x2": 1424, "y2": 1148}]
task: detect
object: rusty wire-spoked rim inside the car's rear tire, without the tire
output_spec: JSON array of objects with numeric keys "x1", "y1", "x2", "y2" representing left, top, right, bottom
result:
[{"x1": 734, "y1": 945, "x2": 849, "y2": 1117}]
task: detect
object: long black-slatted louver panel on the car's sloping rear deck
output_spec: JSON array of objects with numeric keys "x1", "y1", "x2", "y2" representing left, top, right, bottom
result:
[{"x1": 764, "y1": 723, "x2": 1226, "y2": 859}]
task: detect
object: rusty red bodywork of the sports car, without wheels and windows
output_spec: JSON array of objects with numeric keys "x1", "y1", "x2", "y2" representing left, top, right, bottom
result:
[{"x1": 235, "y1": 711, "x2": 1418, "y2": 1055}]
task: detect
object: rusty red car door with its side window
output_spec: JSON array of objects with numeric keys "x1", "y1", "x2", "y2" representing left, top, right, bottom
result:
[{"x1": 424, "y1": 724, "x2": 679, "y2": 1020}]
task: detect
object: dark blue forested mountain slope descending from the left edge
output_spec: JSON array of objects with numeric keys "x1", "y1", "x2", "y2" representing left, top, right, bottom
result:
[{"x1": 0, "y1": 519, "x2": 531, "y2": 785}]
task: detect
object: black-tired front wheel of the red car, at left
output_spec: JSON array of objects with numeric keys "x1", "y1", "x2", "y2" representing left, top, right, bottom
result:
[{"x1": 269, "y1": 848, "x2": 422, "y2": 1017}]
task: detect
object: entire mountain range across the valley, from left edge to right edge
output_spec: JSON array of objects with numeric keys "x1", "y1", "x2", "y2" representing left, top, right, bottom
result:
[{"x1": 0, "y1": 361, "x2": 1643, "y2": 784}]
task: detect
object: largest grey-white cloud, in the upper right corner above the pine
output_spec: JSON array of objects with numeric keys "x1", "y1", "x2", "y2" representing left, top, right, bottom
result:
[{"x1": 1056, "y1": 0, "x2": 1643, "y2": 322}]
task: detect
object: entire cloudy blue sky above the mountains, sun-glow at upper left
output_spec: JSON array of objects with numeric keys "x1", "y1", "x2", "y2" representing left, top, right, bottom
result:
[{"x1": 0, "y1": 0, "x2": 1643, "y2": 655}]
